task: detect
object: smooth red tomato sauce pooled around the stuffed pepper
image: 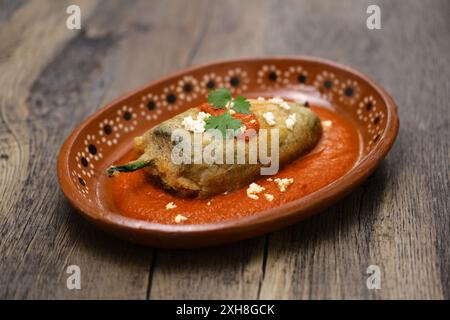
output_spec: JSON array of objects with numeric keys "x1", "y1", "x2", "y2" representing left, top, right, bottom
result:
[{"x1": 107, "y1": 106, "x2": 360, "y2": 224}]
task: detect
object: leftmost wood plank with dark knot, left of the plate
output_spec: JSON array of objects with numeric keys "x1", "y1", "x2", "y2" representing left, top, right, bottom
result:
[{"x1": 0, "y1": 1, "x2": 206, "y2": 299}]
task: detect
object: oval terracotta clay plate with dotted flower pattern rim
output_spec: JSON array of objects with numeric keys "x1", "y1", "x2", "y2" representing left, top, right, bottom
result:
[{"x1": 58, "y1": 57, "x2": 399, "y2": 248}]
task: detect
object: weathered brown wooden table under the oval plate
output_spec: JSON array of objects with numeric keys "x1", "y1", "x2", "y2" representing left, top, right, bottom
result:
[{"x1": 0, "y1": 0, "x2": 450, "y2": 299}]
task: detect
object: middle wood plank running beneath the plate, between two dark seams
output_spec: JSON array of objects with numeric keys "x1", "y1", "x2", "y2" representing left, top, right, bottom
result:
[{"x1": 150, "y1": 0, "x2": 269, "y2": 299}]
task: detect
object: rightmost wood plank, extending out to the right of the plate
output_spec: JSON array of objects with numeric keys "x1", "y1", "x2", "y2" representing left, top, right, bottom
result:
[{"x1": 261, "y1": 1, "x2": 450, "y2": 299}]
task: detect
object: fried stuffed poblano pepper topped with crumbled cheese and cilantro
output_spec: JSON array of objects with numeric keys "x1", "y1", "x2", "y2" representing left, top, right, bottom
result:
[{"x1": 107, "y1": 89, "x2": 322, "y2": 198}]
